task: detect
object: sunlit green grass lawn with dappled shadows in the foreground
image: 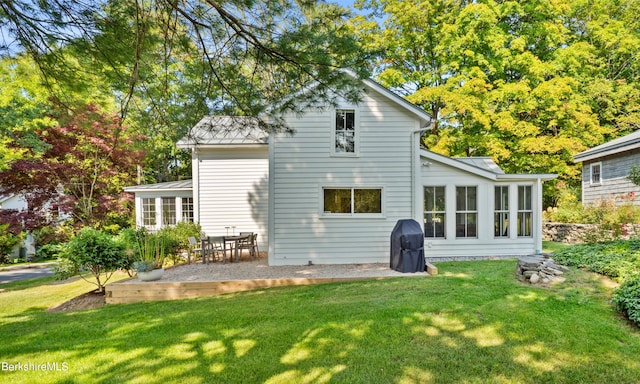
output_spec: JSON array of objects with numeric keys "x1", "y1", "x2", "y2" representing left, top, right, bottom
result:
[{"x1": 0, "y1": 260, "x2": 640, "y2": 384}]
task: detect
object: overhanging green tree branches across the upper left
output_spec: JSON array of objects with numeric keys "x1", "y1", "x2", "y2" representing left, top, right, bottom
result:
[{"x1": 0, "y1": 0, "x2": 367, "y2": 129}]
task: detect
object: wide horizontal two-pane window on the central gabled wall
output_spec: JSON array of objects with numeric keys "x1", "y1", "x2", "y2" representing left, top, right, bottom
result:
[{"x1": 323, "y1": 188, "x2": 382, "y2": 214}]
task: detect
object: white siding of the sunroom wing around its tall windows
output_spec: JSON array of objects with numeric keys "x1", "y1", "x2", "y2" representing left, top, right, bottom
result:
[{"x1": 420, "y1": 160, "x2": 541, "y2": 260}]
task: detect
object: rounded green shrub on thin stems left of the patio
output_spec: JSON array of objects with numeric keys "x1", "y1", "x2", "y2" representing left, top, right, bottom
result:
[{"x1": 63, "y1": 227, "x2": 130, "y2": 292}]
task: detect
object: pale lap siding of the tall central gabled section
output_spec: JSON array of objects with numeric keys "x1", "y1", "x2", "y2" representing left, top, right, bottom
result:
[{"x1": 270, "y1": 94, "x2": 417, "y2": 265}]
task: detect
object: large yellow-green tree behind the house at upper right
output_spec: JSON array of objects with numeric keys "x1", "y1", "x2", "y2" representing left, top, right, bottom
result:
[{"x1": 353, "y1": 0, "x2": 640, "y2": 204}]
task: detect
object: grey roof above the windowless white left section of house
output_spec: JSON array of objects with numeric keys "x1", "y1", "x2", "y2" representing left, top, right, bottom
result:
[{"x1": 176, "y1": 116, "x2": 269, "y2": 148}]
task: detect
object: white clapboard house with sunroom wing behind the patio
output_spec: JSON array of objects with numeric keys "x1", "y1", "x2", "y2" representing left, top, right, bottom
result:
[{"x1": 127, "y1": 77, "x2": 555, "y2": 265}]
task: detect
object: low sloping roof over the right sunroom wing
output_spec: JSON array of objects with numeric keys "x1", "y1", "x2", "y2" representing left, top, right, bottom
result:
[{"x1": 420, "y1": 148, "x2": 558, "y2": 181}]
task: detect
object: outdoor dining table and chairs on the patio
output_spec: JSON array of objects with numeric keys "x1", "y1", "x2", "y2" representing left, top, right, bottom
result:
[{"x1": 189, "y1": 232, "x2": 259, "y2": 264}]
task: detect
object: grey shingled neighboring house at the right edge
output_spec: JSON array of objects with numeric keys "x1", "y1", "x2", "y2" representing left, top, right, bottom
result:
[{"x1": 573, "y1": 130, "x2": 640, "y2": 205}]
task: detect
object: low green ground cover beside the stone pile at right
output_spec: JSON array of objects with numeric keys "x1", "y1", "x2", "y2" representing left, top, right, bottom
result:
[{"x1": 553, "y1": 238, "x2": 640, "y2": 325}]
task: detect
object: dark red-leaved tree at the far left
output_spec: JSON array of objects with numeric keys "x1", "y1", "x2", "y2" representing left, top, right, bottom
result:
[{"x1": 0, "y1": 104, "x2": 144, "y2": 229}]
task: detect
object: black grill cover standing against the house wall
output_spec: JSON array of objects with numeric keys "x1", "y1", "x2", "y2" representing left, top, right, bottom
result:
[{"x1": 389, "y1": 219, "x2": 425, "y2": 273}]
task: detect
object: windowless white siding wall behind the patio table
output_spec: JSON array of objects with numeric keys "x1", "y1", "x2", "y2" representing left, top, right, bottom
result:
[{"x1": 200, "y1": 145, "x2": 269, "y2": 251}]
